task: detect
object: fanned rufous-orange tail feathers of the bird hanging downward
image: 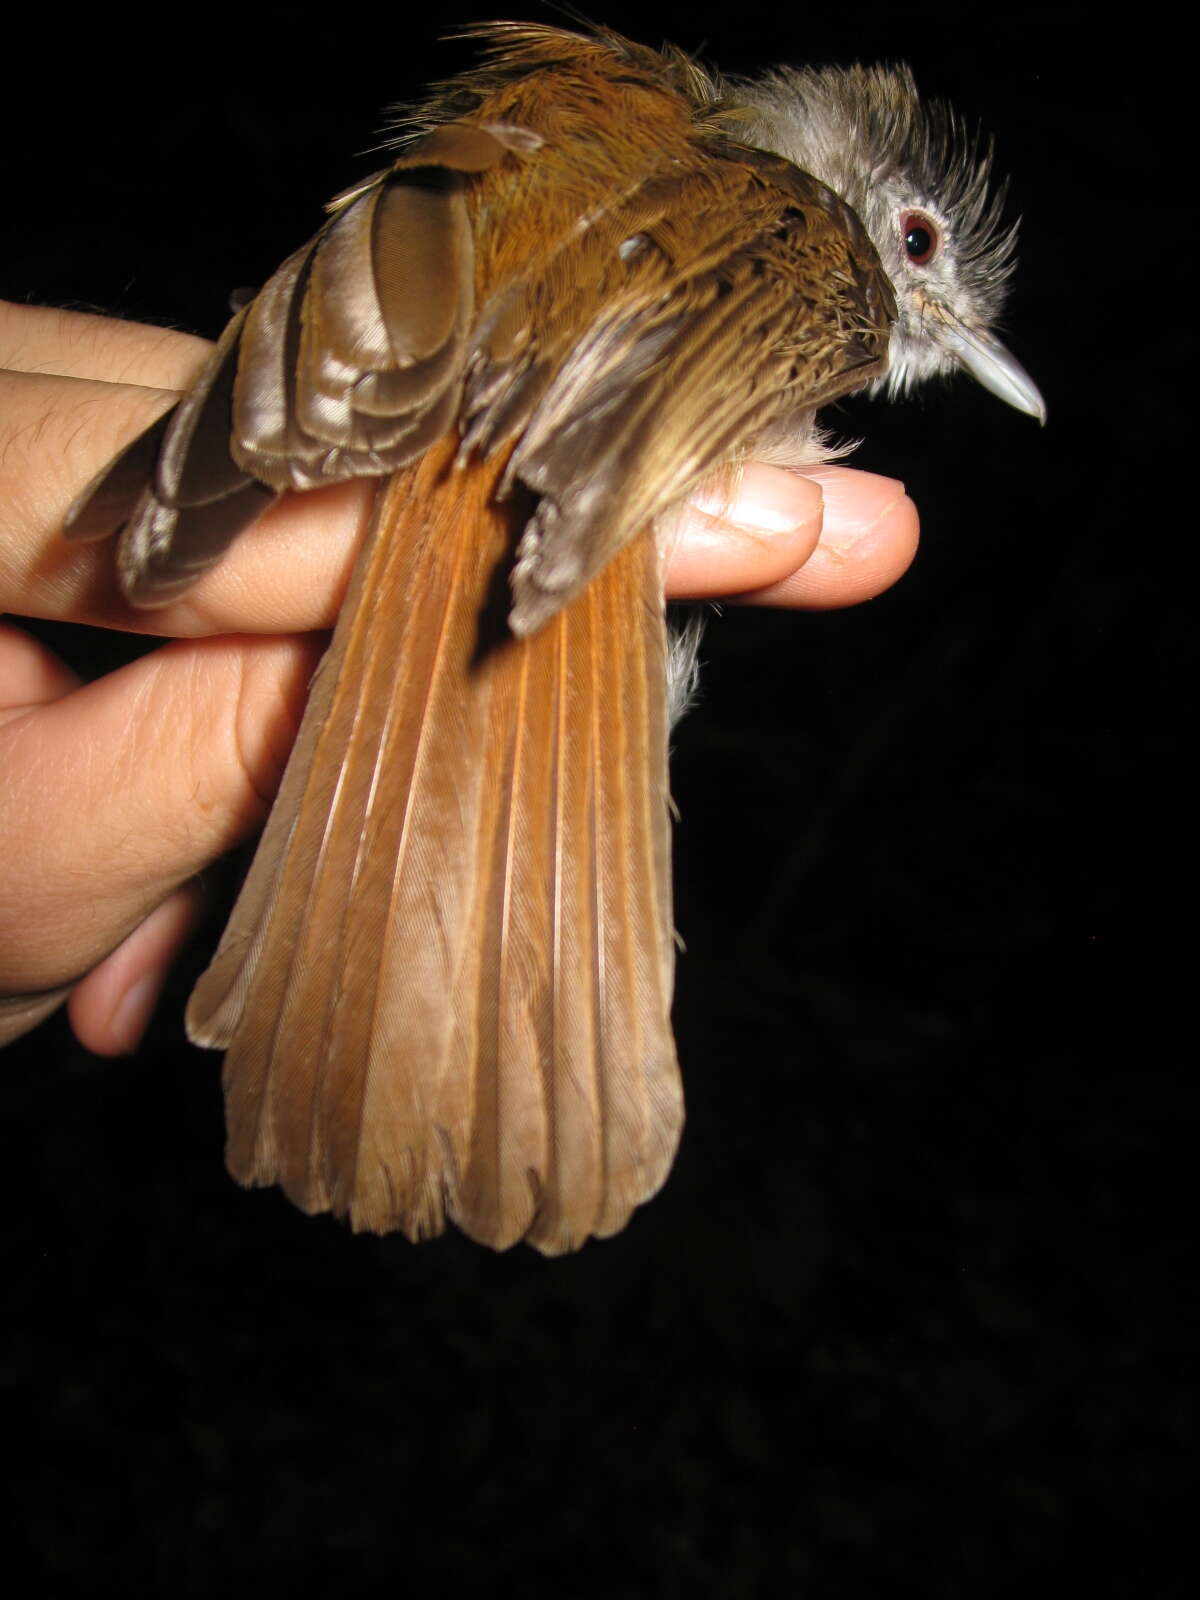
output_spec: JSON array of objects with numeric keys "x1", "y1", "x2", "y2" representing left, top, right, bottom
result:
[{"x1": 189, "y1": 445, "x2": 683, "y2": 1253}]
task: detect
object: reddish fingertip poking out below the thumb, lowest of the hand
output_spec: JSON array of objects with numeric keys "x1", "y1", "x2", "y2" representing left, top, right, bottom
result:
[{"x1": 67, "y1": 882, "x2": 203, "y2": 1056}]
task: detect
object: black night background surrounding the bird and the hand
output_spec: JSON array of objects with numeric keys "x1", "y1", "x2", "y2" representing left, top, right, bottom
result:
[{"x1": 0, "y1": 0, "x2": 1195, "y2": 1600}]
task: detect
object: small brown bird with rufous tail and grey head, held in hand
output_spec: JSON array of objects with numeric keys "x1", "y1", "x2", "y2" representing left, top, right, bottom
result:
[{"x1": 69, "y1": 24, "x2": 1042, "y2": 1254}]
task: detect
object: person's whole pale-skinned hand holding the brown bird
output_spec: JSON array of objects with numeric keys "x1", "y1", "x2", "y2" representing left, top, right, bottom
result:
[{"x1": 0, "y1": 301, "x2": 918, "y2": 1054}]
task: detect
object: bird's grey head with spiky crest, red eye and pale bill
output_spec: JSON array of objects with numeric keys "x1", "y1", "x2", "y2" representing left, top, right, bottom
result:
[{"x1": 736, "y1": 67, "x2": 1046, "y2": 421}]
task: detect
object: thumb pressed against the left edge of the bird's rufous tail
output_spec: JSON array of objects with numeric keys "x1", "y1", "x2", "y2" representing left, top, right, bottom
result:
[{"x1": 0, "y1": 635, "x2": 323, "y2": 995}]
